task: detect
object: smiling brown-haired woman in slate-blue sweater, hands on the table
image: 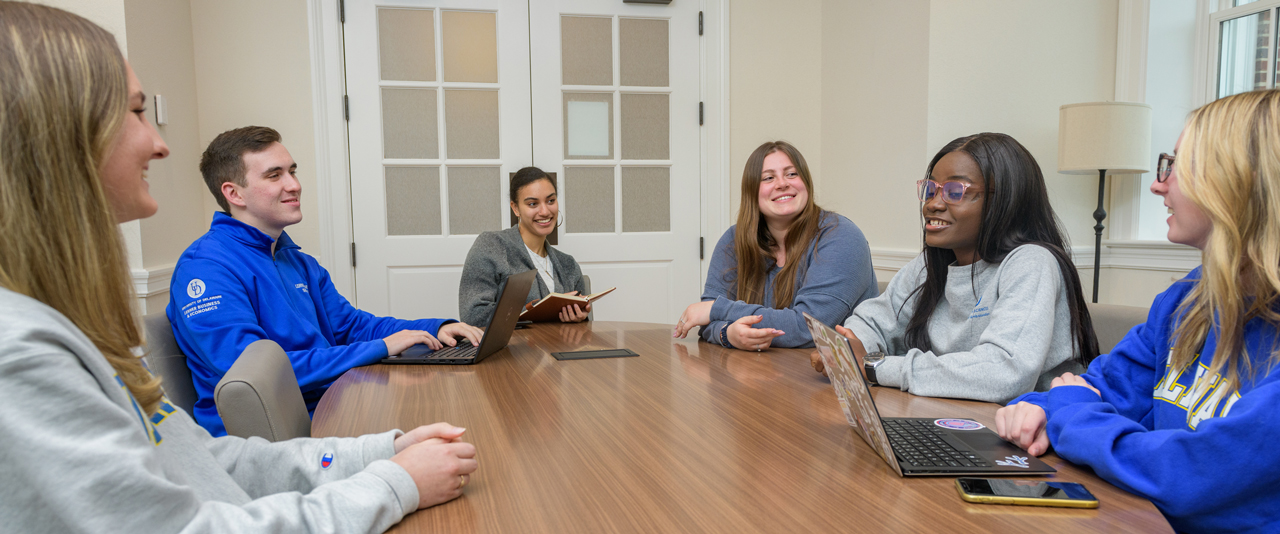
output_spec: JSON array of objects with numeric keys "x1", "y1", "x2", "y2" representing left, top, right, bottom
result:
[{"x1": 673, "y1": 141, "x2": 877, "y2": 351}]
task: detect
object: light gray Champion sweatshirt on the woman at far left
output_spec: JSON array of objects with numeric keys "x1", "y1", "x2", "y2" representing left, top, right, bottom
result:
[{"x1": 0, "y1": 288, "x2": 419, "y2": 533}]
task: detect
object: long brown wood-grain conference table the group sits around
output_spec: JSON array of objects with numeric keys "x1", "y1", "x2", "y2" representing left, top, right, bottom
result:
[{"x1": 312, "y1": 321, "x2": 1171, "y2": 533}]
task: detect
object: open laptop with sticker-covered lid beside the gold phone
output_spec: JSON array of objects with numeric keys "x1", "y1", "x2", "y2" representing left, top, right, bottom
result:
[{"x1": 804, "y1": 309, "x2": 1056, "y2": 476}]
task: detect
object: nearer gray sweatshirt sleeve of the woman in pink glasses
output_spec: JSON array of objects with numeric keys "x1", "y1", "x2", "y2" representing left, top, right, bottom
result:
[{"x1": 850, "y1": 246, "x2": 1064, "y2": 403}]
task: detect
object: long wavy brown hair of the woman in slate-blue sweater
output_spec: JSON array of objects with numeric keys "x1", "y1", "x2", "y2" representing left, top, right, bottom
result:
[{"x1": 724, "y1": 141, "x2": 824, "y2": 310}]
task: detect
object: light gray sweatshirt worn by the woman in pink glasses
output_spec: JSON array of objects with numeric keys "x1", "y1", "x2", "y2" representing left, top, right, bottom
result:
[{"x1": 845, "y1": 245, "x2": 1084, "y2": 403}]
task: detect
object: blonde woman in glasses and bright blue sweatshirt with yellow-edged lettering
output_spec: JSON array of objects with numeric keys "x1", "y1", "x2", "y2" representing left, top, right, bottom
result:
[{"x1": 996, "y1": 90, "x2": 1280, "y2": 531}]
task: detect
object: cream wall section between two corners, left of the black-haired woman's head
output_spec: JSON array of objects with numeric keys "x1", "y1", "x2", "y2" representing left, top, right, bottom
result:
[{"x1": 818, "y1": 0, "x2": 932, "y2": 280}]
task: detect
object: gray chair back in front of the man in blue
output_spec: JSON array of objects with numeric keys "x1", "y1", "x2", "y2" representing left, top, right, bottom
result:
[{"x1": 214, "y1": 339, "x2": 311, "y2": 442}]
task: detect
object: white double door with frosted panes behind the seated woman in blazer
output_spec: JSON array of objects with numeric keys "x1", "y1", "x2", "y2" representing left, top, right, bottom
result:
[{"x1": 343, "y1": 0, "x2": 714, "y2": 323}]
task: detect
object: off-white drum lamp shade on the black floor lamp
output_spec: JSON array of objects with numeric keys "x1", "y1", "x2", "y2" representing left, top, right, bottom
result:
[{"x1": 1057, "y1": 102, "x2": 1151, "y2": 175}]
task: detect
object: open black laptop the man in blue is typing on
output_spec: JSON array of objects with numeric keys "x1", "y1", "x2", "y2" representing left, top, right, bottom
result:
[{"x1": 381, "y1": 270, "x2": 538, "y2": 365}]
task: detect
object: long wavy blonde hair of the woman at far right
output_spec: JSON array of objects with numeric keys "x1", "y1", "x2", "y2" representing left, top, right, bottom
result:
[{"x1": 1171, "y1": 90, "x2": 1280, "y2": 391}]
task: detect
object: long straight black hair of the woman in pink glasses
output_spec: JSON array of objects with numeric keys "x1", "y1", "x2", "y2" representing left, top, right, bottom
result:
[{"x1": 906, "y1": 133, "x2": 1098, "y2": 365}]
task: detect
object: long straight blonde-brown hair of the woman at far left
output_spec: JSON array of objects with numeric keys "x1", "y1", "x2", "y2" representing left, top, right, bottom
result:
[{"x1": 0, "y1": 3, "x2": 163, "y2": 414}]
